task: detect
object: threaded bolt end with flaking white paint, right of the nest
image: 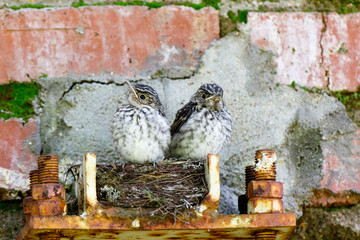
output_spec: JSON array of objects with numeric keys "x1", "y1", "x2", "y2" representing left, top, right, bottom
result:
[{"x1": 254, "y1": 149, "x2": 277, "y2": 181}]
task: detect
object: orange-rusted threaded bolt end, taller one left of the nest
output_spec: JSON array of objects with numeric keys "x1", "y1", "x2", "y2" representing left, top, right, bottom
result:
[{"x1": 38, "y1": 155, "x2": 59, "y2": 184}]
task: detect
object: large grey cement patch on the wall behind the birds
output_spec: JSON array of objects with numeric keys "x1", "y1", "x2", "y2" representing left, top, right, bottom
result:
[{"x1": 38, "y1": 32, "x2": 357, "y2": 216}]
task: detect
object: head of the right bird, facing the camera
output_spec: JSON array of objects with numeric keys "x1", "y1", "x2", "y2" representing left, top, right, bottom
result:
[{"x1": 191, "y1": 84, "x2": 224, "y2": 111}]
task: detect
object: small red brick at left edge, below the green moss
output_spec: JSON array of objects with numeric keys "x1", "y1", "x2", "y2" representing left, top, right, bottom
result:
[{"x1": 0, "y1": 118, "x2": 39, "y2": 190}]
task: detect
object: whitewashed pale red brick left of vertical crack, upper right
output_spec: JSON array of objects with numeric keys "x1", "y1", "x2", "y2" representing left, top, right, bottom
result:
[{"x1": 248, "y1": 12, "x2": 327, "y2": 88}]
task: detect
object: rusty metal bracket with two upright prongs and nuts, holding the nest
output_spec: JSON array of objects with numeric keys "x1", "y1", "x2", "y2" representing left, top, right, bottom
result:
[{"x1": 17, "y1": 153, "x2": 296, "y2": 240}]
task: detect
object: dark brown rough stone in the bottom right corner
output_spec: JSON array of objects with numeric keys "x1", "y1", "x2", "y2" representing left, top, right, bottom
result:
[{"x1": 289, "y1": 205, "x2": 360, "y2": 240}]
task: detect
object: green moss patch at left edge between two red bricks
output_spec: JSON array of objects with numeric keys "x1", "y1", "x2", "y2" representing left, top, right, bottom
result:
[{"x1": 0, "y1": 82, "x2": 39, "y2": 122}]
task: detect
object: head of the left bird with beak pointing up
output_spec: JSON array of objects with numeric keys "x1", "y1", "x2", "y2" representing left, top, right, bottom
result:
[{"x1": 126, "y1": 81, "x2": 164, "y2": 115}]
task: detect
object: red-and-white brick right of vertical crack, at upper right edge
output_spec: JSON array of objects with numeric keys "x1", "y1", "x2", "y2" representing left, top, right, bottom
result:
[{"x1": 322, "y1": 13, "x2": 360, "y2": 91}]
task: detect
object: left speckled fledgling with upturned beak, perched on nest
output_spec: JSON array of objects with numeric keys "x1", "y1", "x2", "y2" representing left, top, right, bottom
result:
[{"x1": 111, "y1": 81, "x2": 171, "y2": 165}]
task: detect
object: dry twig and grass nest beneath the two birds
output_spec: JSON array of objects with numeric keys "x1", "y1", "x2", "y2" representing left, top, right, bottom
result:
[{"x1": 96, "y1": 160, "x2": 207, "y2": 213}]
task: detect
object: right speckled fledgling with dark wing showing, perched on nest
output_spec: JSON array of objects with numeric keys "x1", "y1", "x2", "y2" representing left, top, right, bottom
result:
[{"x1": 170, "y1": 84, "x2": 232, "y2": 160}]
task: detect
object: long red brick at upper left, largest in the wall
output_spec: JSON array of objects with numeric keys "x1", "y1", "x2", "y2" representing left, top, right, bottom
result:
[{"x1": 0, "y1": 6, "x2": 219, "y2": 84}]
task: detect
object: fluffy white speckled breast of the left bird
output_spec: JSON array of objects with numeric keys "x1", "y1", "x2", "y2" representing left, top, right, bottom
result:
[{"x1": 112, "y1": 105, "x2": 170, "y2": 163}]
